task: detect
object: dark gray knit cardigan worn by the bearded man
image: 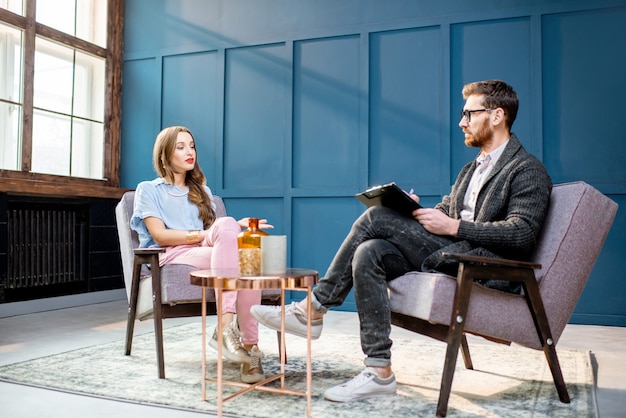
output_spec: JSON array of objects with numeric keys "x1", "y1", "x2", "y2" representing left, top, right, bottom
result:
[{"x1": 422, "y1": 134, "x2": 552, "y2": 293}]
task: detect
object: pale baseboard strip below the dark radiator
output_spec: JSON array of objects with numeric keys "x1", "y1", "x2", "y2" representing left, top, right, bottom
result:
[{"x1": 0, "y1": 289, "x2": 126, "y2": 318}]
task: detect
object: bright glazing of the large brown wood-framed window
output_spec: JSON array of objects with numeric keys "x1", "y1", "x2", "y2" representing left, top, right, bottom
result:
[{"x1": 0, "y1": 0, "x2": 108, "y2": 180}]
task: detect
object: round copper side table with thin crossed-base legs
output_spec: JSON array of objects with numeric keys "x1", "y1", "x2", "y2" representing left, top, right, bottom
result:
[{"x1": 190, "y1": 268, "x2": 318, "y2": 417}]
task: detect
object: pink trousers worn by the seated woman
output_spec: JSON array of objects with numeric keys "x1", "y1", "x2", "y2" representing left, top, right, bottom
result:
[{"x1": 159, "y1": 216, "x2": 261, "y2": 344}]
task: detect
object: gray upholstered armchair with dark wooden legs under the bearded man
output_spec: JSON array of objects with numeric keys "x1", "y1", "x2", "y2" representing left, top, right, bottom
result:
[{"x1": 390, "y1": 182, "x2": 617, "y2": 416}]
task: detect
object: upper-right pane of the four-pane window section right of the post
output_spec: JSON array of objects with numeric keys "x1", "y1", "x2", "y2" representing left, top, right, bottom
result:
[{"x1": 74, "y1": 52, "x2": 105, "y2": 122}]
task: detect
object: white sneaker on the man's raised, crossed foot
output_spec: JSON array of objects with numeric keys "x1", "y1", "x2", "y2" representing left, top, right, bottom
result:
[{"x1": 250, "y1": 302, "x2": 324, "y2": 340}]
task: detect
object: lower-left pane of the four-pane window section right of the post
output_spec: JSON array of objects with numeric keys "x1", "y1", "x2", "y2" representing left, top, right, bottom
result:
[{"x1": 31, "y1": 110, "x2": 71, "y2": 176}]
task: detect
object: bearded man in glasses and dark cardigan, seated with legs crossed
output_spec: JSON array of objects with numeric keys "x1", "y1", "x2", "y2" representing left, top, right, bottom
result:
[{"x1": 251, "y1": 80, "x2": 552, "y2": 402}]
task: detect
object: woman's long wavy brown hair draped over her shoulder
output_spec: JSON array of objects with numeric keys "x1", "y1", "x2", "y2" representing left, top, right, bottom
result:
[{"x1": 152, "y1": 126, "x2": 215, "y2": 229}]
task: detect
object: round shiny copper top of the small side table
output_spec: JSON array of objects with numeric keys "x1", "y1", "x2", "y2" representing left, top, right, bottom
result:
[{"x1": 189, "y1": 268, "x2": 318, "y2": 290}]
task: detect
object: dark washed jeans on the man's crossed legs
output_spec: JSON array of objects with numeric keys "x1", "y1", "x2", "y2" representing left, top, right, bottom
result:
[{"x1": 311, "y1": 206, "x2": 452, "y2": 367}]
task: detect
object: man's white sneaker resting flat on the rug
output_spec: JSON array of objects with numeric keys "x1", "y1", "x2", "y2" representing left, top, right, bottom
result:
[{"x1": 324, "y1": 367, "x2": 396, "y2": 402}]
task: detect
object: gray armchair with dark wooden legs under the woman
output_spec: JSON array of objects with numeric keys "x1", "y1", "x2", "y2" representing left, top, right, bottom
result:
[{"x1": 115, "y1": 192, "x2": 280, "y2": 379}]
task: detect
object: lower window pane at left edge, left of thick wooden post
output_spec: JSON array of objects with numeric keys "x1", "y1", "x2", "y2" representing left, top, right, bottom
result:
[{"x1": 0, "y1": 102, "x2": 22, "y2": 170}]
